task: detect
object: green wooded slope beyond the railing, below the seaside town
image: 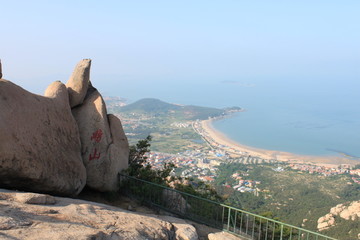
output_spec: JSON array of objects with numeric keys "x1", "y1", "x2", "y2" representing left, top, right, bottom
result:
[{"x1": 214, "y1": 163, "x2": 360, "y2": 240}]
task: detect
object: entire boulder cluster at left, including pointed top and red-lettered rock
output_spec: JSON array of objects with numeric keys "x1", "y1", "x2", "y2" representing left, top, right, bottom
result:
[{"x1": 0, "y1": 59, "x2": 129, "y2": 195}]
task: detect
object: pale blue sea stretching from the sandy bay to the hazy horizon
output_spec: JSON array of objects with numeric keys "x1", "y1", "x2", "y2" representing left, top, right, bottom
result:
[{"x1": 105, "y1": 76, "x2": 360, "y2": 160}]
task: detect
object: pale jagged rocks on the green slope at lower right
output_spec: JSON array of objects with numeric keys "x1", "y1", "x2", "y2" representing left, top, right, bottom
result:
[{"x1": 317, "y1": 201, "x2": 360, "y2": 231}]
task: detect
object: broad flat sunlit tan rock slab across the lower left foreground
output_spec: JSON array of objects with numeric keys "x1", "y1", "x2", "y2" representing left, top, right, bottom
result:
[{"x1": 0, "y1": 189, "x2": 198, "y2": 240}]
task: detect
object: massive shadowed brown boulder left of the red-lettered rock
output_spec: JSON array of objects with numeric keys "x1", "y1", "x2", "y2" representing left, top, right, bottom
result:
[{"x1": 0, "y1": 79, "x2": 86, "y2": 195}]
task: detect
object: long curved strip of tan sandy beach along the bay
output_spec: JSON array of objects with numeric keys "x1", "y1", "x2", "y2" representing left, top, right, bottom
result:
[{"x1": 201, "y1": 120, "x2": 359, "y2": 167}]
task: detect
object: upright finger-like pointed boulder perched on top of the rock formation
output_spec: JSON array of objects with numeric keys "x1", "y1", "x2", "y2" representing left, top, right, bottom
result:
[{"x1": 66, "y1": 59, "x2": 91, "y2": 107}]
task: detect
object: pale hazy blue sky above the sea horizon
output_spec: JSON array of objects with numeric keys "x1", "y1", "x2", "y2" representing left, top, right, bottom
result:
[{"x1": 0, "y1": 0, "x2": 360, "y2": 104}]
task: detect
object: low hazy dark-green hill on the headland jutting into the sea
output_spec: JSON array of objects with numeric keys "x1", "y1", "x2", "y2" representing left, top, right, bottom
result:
[{"x1": 119, "y1": 98, "x2": 241, "y2": 120}]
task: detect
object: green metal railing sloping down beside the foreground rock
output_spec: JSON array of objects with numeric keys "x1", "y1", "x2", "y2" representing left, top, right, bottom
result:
[{"x1": 120, "y1": 174, "x2": 336, "y2": 240}]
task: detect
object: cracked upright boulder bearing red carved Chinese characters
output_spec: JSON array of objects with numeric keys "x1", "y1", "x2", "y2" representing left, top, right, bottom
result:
[{"x1": 72, "y1": 84, "x2": 129, "y2": 191}]
